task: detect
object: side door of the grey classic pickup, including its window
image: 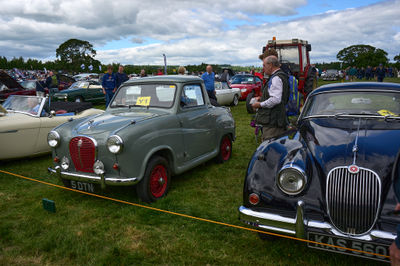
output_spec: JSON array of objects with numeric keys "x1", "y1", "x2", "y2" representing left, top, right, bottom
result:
[{"x1": 178, "y1": 84, "x2": 217, "y2": 161}]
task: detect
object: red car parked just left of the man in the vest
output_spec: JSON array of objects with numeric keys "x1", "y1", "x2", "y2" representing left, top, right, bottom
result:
[{"x1": 230, "y1": 74, "x2": 262, "y2": 100}]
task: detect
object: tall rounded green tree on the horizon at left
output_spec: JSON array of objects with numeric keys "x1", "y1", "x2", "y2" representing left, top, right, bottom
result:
[{"x1": 56, "y1": 39, "x2": 100, "y2": 72}]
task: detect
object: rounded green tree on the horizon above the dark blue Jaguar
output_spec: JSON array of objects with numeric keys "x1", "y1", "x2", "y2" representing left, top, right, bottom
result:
[{"x1": 336, "y1": 44, "x2": 389, "y2": 67}]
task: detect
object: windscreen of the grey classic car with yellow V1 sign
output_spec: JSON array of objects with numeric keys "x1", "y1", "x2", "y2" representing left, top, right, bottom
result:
[{"x1": 110, "y1": 84, "x2": 176, "y2": 108}]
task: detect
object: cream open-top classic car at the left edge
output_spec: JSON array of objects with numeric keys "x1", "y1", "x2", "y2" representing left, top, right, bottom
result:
[{"x1": 0, "y1": 95, "x2": 104, "y2": 160}]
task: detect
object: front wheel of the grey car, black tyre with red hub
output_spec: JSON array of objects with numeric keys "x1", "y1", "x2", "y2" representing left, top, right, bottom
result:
[{"x1": 136, "y1": 156, "x2": 171, "y2": 203}]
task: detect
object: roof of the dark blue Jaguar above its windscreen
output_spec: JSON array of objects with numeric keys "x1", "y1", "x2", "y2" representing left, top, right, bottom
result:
[{"x1": 309, "y1": 82, "x2": 400, "y2": 96}]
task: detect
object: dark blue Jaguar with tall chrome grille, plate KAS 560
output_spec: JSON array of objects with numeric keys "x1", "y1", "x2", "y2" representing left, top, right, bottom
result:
[{"x1": 239, "y1": 82, "x2": 400, "y2": 260}]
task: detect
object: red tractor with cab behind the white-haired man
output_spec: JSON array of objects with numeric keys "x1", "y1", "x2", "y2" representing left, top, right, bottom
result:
[{"x1": 246, "y1": 37, "x2": 317, "y2": 112}]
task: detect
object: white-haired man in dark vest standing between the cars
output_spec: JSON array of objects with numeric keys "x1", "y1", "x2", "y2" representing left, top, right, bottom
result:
[{"x1": 252, "y1": 55, "x2": 289, "y2": 141}]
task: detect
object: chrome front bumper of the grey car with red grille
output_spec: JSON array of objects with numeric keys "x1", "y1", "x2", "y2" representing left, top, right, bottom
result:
[{"x1": 47, "y1": 166, "x2": 138, "y2": 189}]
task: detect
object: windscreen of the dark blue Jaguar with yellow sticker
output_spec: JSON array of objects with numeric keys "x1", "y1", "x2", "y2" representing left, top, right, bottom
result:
[{"x1": 303, "y1": 91, "x2": 400, "y2": 117}]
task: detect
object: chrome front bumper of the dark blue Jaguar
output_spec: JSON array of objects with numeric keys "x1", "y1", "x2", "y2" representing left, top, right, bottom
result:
[{"x1": 239, "y1": 201, "x2": 396, "y2": 241}]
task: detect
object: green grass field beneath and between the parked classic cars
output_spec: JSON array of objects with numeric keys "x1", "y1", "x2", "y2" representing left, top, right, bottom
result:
[{"x1": 0, "y1": 78, "x2": 398, "y2": 265}]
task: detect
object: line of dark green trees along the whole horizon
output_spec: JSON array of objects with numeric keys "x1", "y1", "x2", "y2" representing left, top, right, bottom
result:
[{"x1": 0, "y1": 39, "x2": 400, "y2": 74}]
